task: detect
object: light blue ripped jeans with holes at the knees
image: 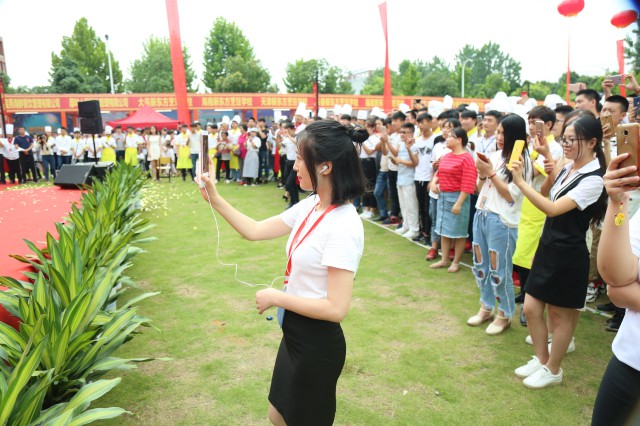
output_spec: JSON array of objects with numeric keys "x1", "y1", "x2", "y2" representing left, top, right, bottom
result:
[{"x1": 473, "y1": 210, "x2": 518, "y2": 318}]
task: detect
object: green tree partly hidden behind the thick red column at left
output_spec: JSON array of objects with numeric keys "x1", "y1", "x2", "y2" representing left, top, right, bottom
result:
[{"x1": 126, "y1": 36, "x2": 196, "y2": 93}]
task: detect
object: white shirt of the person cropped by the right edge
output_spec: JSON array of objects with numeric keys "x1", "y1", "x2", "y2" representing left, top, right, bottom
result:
[{"x1": 612, "y1": 214, "x2": 640, "y2": 371}]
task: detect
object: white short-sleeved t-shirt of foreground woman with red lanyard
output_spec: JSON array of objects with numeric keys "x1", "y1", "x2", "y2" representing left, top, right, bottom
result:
[{"x1": 280, "y1": 195, "x2": 364, "y2": 299}]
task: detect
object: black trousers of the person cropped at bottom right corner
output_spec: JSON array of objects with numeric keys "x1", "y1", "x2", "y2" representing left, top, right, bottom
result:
[{"x1": 591, "y1": 355, "x2": 640, "y2": 426}]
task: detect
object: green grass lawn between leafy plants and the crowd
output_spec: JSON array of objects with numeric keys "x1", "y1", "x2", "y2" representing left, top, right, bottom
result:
[{"x1": 97, "y1": 180, "x2": 614, "y2": 425}]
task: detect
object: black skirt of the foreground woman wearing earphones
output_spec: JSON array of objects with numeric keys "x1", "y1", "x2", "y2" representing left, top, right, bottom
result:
[{"x1": 269, "y1": 311, "x2": 347, "y2": 426}]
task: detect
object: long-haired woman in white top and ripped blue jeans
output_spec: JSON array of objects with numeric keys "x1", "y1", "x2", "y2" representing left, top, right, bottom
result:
[{"x1": 467, "y1": 114, "x2": 533, "y2": 336}]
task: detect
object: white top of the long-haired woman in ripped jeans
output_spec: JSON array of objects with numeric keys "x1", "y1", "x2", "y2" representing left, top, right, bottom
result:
[{"x1": 476, "y1": 150, "x2": 531, "y2": 228}]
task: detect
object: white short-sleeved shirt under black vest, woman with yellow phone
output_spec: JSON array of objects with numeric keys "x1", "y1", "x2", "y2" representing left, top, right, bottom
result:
[{"x1": 550, "y1": 158, "x2": 604, "y2": 210}]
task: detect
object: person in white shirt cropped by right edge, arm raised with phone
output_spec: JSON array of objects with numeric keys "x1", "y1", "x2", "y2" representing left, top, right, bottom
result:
[{"x1": 591, "y1": 154, "x2": 640, "y2": 426}]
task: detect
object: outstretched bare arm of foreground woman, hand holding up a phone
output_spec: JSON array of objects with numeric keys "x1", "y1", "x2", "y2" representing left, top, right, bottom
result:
[{"x1": 198, "y1": 156, "x2": 291, "y2": 241}]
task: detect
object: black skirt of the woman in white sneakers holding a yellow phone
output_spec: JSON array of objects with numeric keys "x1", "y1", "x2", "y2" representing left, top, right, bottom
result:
[{"x1": 525, "y1": 242, "x2": 589, "y2": 309}]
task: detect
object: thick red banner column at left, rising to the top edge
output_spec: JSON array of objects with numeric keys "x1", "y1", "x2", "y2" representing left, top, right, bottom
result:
[{"x1": 166, "y1": 0, "x2": 191, "y2": 123}]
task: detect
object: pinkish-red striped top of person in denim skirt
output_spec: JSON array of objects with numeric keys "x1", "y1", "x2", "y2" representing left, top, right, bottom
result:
[{"x1": 438, "y1": 152, "x2": 478, "y2": 194}]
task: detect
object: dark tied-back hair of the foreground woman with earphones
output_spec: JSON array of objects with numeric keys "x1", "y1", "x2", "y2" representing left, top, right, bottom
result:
[{"x1": 297, "y1": 120, "x2": 369, "y2": 205}]
